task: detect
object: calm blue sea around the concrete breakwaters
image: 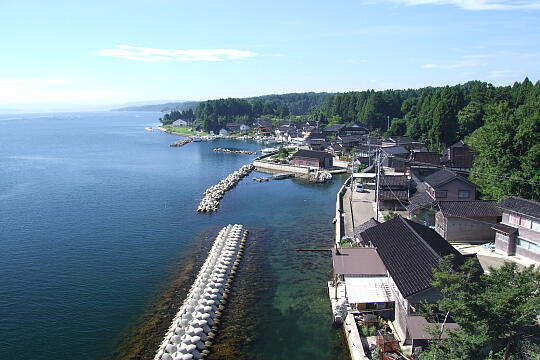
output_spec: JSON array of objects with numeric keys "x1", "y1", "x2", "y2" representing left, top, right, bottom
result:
[{"x1": 0, "y1": 112, "x2": 348, "y2": 360}]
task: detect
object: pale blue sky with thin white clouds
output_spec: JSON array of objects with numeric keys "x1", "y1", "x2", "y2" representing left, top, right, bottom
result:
[{"x1": 0, "y1": 0, "x2": 540, "y2": 109}]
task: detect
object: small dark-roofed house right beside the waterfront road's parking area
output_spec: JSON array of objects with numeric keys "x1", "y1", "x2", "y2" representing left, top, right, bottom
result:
[{"x1": 379, "y1": 175, "x2": 410, "y2": 210}]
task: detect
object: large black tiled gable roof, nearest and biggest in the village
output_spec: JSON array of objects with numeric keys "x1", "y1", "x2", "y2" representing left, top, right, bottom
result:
[{"x1": 361, "y1": 216, "x2": 465, "y2": 297}]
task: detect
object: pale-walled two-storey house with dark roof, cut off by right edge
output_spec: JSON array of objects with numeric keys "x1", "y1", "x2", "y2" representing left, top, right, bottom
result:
[{"x1": 493, "y1": 196, "x2": 540, "y2": 261}]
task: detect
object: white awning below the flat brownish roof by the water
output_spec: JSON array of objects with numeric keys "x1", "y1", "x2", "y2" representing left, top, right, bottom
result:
[{"x1": 345, "y1": 276, "x2": 394, "y2": 304}]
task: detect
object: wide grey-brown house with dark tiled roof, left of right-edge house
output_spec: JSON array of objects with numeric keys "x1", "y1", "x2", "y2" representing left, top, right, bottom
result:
[{"x1": 435, "y1": 200, "x2": 501, "y2": 243}]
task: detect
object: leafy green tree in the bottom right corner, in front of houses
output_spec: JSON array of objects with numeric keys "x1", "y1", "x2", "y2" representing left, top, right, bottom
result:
[{"x1": 422, "y1": 258, "x2": 540, "y2": 360}]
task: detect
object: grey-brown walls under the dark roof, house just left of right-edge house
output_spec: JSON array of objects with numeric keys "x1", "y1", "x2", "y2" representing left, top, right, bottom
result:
[{"x1": 435, "y1": 215, "x2": 497, "y2": 243}]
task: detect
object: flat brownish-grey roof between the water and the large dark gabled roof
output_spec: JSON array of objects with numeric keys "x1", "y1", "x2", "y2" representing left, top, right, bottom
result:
[{"x1": 332, "y1": 247, "x2": 386, "y2": 275}]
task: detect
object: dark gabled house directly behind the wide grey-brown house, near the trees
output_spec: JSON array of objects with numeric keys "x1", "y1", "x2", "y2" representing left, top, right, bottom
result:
[{"x1": 424, "y1": 169, "x2": 476, "y2": 201}]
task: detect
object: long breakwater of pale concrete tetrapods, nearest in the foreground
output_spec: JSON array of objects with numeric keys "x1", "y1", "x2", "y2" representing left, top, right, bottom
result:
[{"x1": 154, "y1": 225, "x2": 248, "y2": 360}]
